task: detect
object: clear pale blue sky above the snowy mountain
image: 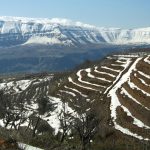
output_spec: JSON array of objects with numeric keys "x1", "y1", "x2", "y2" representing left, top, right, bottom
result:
[{"x1": 0, "y1": 0, "x2": 150, "y2": 28}]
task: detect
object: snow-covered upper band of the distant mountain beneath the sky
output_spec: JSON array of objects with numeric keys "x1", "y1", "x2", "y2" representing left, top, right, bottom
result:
[{"x1": 0, "y1": 17, "x2": 150, "y2": 47}]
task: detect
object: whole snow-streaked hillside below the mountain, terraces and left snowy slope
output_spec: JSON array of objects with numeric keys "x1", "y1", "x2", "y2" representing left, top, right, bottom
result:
[{"x1": 0, "y1": 54, "x2": 150, "y2": 149}]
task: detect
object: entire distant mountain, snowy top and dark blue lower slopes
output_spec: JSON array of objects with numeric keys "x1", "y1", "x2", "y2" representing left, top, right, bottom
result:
[{"x1": 0, "y1": 17, "x2": 150, "y2": 73}]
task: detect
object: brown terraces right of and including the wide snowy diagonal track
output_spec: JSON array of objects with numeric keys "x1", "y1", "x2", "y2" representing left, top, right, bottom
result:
[{"x1": 108, "y1": 56, "x2": 150, "y2": 140}]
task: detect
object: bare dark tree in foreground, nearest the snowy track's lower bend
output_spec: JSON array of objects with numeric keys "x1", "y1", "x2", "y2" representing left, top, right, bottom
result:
[{"x1": 70, "y1": 97, "x2": 101, "y2": 150}]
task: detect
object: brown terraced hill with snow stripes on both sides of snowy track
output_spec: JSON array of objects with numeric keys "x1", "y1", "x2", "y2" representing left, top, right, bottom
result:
[{"x1": 50, "y1": 55, "x2": 150, "y2": 140}]
